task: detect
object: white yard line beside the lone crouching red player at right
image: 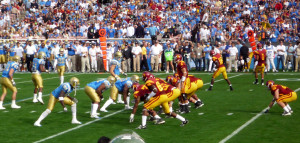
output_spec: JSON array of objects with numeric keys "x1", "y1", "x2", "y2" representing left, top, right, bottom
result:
[{"x1": 219, "y1": 88, "x2": 300, "y2": 143}]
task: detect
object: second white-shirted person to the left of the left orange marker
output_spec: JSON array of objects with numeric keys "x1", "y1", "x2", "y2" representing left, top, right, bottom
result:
[{"x1": 81, "y1": 42, "x2": 90, "y2": 73}]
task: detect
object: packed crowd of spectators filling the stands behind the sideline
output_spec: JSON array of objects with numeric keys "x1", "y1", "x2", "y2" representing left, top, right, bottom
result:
[{"x1": 0, "y1": 0, "x2": 300, "y2": 72}]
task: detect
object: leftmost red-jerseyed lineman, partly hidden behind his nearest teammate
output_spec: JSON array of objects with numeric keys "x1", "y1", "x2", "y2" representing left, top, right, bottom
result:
[{"x1": 129, "y1": 82, "x2": 165, "y2": 124}]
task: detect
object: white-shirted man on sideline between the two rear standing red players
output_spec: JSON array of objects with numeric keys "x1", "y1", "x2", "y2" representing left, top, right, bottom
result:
[{"x1": 227, "y1": 43, "x2": 239, "y2": 72}]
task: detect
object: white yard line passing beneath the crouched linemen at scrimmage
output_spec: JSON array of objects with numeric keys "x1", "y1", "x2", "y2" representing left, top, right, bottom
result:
[{"x1": 34, "y1": 74, "x2": 242, "y2": 143}]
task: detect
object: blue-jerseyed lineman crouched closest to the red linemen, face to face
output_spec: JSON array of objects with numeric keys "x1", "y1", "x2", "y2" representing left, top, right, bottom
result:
[{"x1": 100, "y1": 75, "x2": 139, "y2": 112}]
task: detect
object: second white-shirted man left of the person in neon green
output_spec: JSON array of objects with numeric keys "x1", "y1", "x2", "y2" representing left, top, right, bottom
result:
[{"x1": 131, "y1": 42, "x2": 142, "y2": 72}]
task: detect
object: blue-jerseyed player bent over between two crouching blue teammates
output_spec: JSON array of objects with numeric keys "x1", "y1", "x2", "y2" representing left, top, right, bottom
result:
[{"x1": 84, "y1": 76, "x2": 116, "y2": 119}]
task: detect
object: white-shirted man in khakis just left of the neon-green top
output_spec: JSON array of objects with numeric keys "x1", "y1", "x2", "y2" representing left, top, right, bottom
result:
[{"x1": 150, "y1": 41, "x2": 162, "y2": 72}]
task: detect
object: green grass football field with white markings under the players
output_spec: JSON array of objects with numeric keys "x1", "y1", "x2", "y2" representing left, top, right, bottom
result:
[{"x1": 0, "y1": 72, "x2": 300, "y2": 143}]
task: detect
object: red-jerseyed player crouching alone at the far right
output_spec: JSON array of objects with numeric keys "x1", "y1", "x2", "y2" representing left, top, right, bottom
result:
[{"x1": 265, "y1": 80, "x2": 297, "y2": 116}]
